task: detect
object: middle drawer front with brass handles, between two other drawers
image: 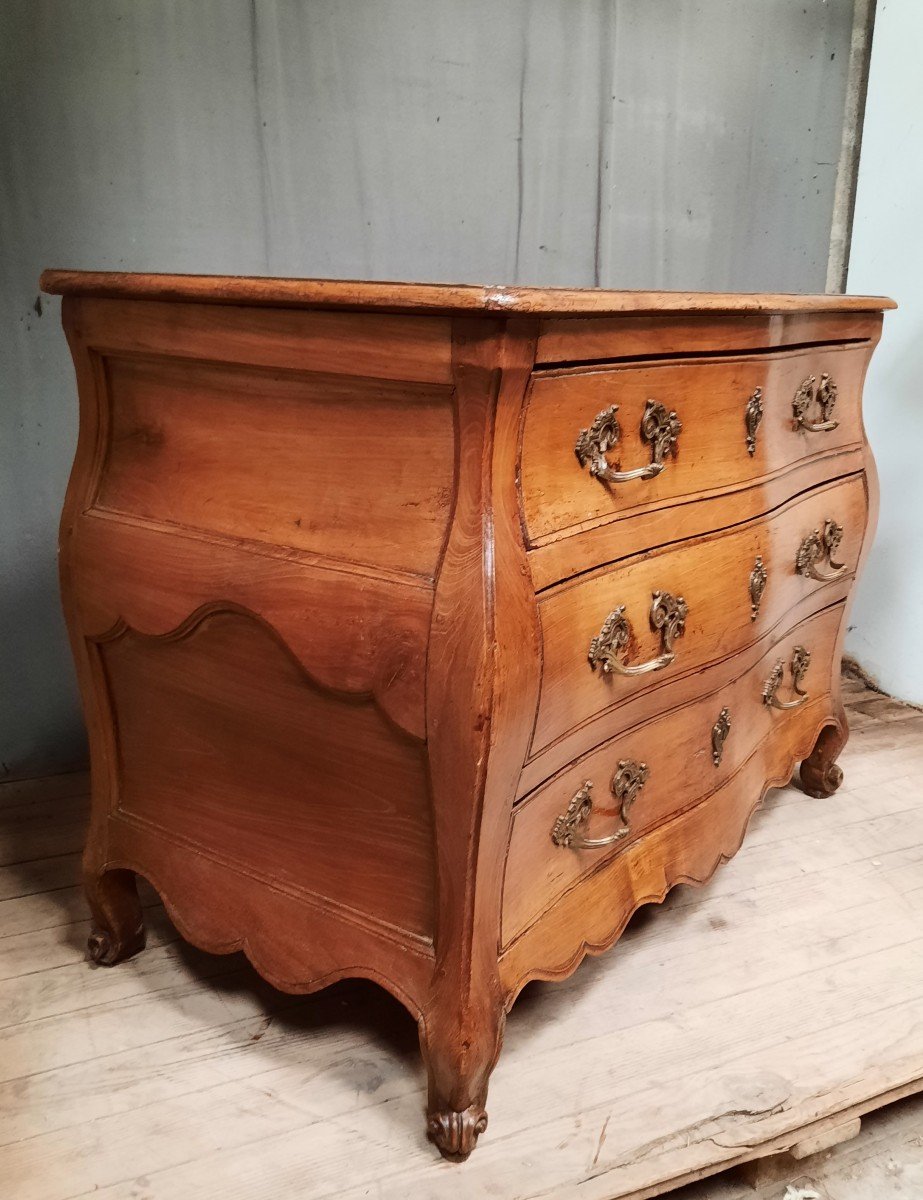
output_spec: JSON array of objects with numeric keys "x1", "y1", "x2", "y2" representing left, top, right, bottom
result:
[{"x1": 532, "y1": 474, "x2": 868, "y2": 756}]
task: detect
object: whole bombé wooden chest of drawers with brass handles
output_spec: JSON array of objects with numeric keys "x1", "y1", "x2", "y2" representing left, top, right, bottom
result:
[{"x1": 43, "y1": 271, "x2": 892, "y2": 1158}]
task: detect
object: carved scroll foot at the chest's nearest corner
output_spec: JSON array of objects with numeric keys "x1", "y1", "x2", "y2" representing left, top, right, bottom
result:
[{"x1": 420, "y1": 988, "x2": 504, "y2": 1163}]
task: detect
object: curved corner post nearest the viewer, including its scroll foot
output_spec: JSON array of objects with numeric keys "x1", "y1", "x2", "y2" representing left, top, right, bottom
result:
[{"x1": 420, "y1": 318, "x2": 540, "y2": 1159}]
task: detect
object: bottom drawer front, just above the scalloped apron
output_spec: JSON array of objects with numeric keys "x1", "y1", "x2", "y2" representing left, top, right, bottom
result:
[{"x1": 503, "y1": 605, "x2": 843, "y2": 946}]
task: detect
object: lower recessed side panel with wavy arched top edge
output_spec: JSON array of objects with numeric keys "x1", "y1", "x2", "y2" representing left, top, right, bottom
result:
[{"x1": 98, "y1": 611, "x2": 433, "y2": 941}]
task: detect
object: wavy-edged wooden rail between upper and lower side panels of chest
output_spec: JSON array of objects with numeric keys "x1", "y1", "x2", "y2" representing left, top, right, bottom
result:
[{"x1": 68, "y1": 509, "x2": 432, "y2": 738}]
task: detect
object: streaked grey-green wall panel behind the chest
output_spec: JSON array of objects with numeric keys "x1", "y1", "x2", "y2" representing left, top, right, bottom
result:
[{"x1": 0, "y1": 0, "x2": 853, "y2": 778}]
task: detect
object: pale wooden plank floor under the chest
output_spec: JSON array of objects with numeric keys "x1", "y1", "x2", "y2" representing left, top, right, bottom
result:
[{"x1": 0, "y1": 684, "x2": 923, "y2": 1200}]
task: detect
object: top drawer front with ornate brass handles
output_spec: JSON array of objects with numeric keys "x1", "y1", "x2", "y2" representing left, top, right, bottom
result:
[{"x1": 521, "y1": 343, "x2": 871, "y2": 545}]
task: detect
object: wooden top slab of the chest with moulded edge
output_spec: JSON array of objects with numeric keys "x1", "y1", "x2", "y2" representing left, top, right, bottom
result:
[{"x1": 40, "y1": 270, "x2": 897, "y2": 317}]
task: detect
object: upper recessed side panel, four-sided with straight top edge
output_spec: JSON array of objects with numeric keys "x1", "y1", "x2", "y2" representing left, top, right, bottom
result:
[{"x1": 96, "y1": 355, "x2": 452, "y2": 577}]
